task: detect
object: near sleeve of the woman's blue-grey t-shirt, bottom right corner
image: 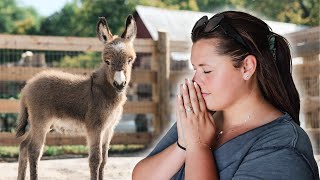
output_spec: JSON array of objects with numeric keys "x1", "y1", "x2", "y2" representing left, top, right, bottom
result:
[{"x1": 232, "y1": 147, "x2": 319, "y2": 180}]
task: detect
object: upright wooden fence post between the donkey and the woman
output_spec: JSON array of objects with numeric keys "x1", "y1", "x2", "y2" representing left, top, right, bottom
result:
[{"x1": 156, "y1": 31, "x2": 170, "y2": 135}]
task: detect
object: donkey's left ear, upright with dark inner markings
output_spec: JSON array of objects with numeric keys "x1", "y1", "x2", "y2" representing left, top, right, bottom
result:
[{"x1": 96, "y1": 17, "x2": 113, "y2": 43}]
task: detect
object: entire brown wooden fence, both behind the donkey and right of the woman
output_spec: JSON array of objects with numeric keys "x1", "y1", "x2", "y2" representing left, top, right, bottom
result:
[{"x1": 0, "y1": 27, "x2": 320, "y2": 152}]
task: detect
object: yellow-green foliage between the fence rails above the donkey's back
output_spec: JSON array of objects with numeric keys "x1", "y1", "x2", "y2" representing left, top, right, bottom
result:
[{"x1": 55, "y1": 52, "x2": 101, "y2": 68}]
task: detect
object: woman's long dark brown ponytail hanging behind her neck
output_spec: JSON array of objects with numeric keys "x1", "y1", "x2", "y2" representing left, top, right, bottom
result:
[{"x1": 257, "y1": 32, "x2": 300, "y2": 125}]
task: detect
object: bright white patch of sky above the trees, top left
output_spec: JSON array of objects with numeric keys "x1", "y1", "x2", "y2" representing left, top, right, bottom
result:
[{"x1": 17, "y1": 0, "x2": 71, "y2": 16}]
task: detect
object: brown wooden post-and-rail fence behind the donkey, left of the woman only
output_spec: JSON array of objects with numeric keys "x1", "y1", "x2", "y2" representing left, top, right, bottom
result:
[{"x1": 0, "y1": 32, "x2": 190, "y2": 146}]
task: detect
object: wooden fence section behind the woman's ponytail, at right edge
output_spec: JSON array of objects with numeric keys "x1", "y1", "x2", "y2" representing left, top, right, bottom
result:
[{"x1": 285, "y1": 26, "x2": 320, "y2": 154}]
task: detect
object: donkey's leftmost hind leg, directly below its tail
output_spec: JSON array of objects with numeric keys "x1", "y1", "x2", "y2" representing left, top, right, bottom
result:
[{"x1": 18, "y1": 134, "x2": 30, "y2": 180}]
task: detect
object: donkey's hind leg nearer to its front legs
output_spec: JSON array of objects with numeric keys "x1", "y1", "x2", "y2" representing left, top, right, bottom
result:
[{"x1": 28, "y1": 128, "x2": 48, "y2": 180}]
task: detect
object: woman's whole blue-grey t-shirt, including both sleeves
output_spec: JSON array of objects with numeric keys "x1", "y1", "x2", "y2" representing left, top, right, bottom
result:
[{"x1": 149, "y1": 113, "x2": 319, "y2": 180}]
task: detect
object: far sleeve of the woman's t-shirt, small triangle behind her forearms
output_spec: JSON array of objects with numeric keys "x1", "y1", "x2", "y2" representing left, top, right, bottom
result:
[{"x1": 147, "y1": 123, "x2": 178, "y2": 157}]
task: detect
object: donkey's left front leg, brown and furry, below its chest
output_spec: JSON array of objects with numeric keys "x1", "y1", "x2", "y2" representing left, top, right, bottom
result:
[{"x1": 88, "y1": 129, "x2": 102, "y2": 180}]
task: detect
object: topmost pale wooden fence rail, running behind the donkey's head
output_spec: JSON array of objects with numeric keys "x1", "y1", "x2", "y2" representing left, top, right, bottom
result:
[{"x1": 0, "y1": 34, "x2": 191, "y2": 53}]
